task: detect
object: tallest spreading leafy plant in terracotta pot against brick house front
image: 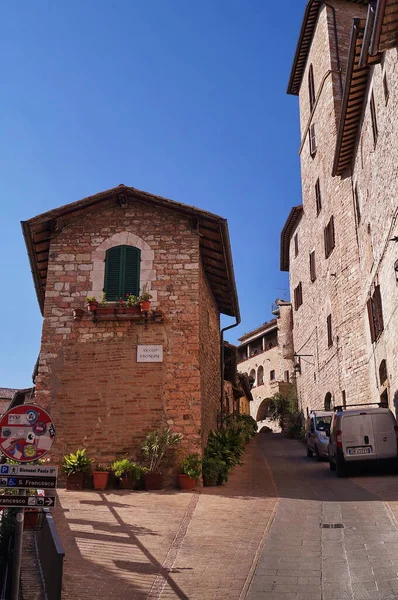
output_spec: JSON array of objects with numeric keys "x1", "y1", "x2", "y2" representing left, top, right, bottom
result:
[{"x1": 142, "y1": 427, "x2": 181, "y2": 490}]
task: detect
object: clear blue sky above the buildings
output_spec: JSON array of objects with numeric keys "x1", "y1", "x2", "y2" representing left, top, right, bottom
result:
[{"x1": 0, "y1": 0, "x2": 306, "y2": 387}]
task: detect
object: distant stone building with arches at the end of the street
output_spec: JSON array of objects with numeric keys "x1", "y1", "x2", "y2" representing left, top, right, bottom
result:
[{"x1": 238, "y1": 300, "x2": 294, "y2": 430}]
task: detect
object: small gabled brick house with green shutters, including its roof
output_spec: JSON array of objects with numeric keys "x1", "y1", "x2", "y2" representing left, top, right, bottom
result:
[{"x1": 22, "y1": 186, "x2": 240, "y2": 460}]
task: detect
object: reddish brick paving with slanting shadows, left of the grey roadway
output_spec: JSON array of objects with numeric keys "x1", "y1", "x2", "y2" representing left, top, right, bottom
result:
[{"x1": 53, "y1": 434, "x2": 277, "y2": 600}]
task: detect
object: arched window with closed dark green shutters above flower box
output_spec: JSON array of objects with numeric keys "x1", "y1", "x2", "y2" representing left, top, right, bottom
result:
[{"x1": 104, "y1": 246, "x2": 141, "y2": 302}]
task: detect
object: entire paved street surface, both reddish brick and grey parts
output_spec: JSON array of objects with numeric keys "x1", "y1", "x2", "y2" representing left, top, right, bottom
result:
[{"x1": 54, "y1": 434, "x2": 398, "y2": 600}]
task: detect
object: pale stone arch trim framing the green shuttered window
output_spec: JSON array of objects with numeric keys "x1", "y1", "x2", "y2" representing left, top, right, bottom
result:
[{"x1": 88, "y1": 231, "x2": 157, "y2": 302}]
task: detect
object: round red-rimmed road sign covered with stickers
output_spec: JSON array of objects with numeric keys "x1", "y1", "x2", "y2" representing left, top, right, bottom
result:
[{"x1": 0, "y1": 404, "x2": 55, "y2": 463}]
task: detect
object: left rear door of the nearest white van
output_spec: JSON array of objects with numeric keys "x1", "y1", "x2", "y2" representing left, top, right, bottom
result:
[{"x1": 341, "y1": 411, "x2": 376, "y2": 461}]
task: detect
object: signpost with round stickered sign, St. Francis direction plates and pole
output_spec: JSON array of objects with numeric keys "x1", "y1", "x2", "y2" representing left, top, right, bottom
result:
[{"x1": 0, "y1": 404, "x2": 57, "y2": 600}]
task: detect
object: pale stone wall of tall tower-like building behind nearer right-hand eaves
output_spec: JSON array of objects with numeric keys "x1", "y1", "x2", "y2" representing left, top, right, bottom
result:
[{"x1": 290, "y1": 0, "x2": 369, "y2": 418}]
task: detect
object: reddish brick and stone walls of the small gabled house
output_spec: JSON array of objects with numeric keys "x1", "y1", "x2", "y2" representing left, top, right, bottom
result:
[{"x1": 36, "y1": 201, "x2": 219, "y2": 460}]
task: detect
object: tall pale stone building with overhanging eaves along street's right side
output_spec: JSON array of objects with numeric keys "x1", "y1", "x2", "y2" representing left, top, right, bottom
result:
[{"x1": 281, "y1": 0, "x2": 398, "y2": 418}]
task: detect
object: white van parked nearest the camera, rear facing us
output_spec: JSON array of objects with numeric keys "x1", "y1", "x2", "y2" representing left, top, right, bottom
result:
[{"x1": 329, "y1": 404, "x2": 398, "y2": 477}]
